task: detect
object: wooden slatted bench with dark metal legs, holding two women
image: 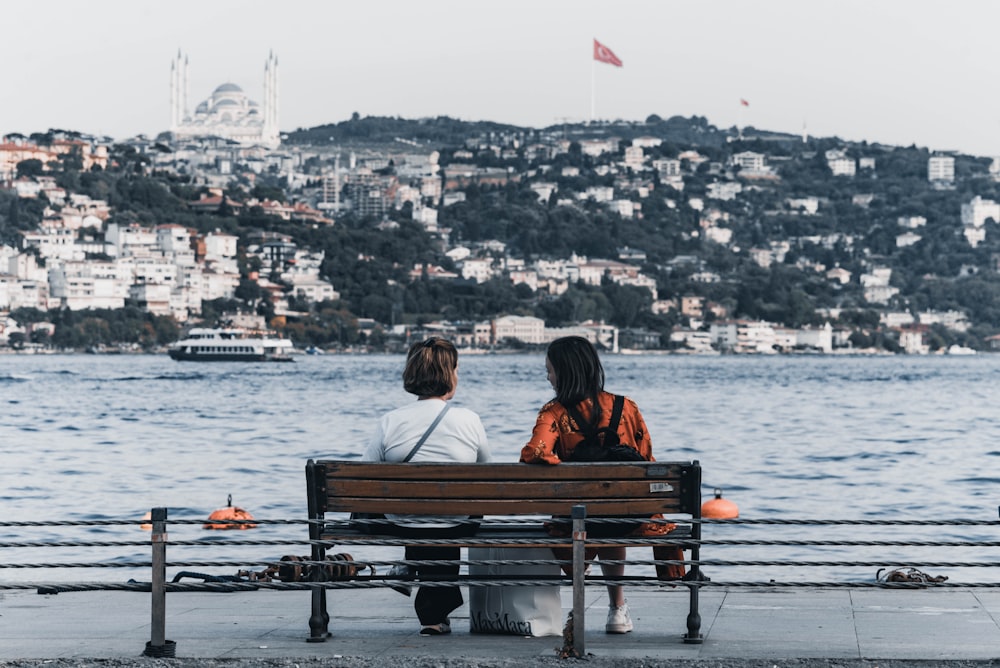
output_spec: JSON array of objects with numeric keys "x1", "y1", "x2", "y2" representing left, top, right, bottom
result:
[{"x1": 306, "y1": 460, "x2": 701, "y2": 648}]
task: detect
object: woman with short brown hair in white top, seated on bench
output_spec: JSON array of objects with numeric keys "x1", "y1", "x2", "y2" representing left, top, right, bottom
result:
[{"x1": 364, "y1": 337, "x2": 490, "y2": 635}]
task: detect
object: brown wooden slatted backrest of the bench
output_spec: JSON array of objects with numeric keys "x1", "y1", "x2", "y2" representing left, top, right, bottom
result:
[{"x1": 306, "y1": 460, "x2": 701, "y2": 518}]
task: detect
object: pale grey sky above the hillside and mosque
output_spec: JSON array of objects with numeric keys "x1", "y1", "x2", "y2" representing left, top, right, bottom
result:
[{"x1": 0, "y1": 0, "x2": 1000, "y2": 156}]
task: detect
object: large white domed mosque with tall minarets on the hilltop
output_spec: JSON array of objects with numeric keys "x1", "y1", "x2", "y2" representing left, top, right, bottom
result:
[{"x1": 170, "y1": 50, "x2": 281, "y2": 148}]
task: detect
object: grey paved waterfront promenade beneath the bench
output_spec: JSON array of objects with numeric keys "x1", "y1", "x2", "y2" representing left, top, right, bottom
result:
[{"x1": 0, "y1": 587, "x2": 1000, "y2": 668}]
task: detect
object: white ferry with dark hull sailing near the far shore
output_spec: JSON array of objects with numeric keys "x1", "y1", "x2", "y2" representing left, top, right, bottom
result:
[{"x1": 167, "y1": 327, "x2": 292, "y2": 362}]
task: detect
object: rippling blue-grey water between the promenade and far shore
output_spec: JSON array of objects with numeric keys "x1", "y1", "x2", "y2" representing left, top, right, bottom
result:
[{"x1": 0, "y1": 355, "x2": 1000, "y2": 581}]
